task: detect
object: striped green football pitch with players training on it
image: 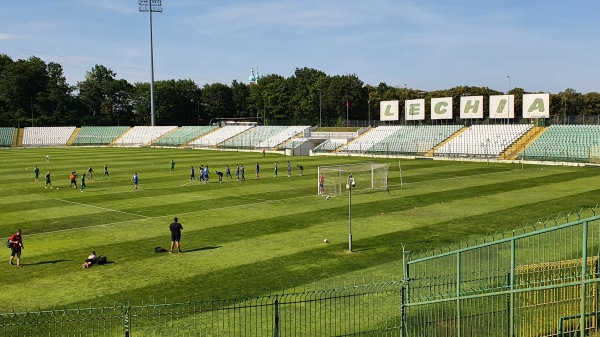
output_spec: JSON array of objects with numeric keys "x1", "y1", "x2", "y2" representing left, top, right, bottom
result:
[{"x1": 0, "y1": 148, "x2": 600, "y2": 312}]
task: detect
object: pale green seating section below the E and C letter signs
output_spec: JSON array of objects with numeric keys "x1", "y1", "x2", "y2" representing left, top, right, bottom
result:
[{"x1": 366, "y1": 125, "x2": 462, "y2": 155}]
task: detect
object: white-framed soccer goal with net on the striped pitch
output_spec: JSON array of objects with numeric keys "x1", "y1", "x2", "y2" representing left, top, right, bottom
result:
[{"x1": 317, "y1": 162, "x2": 390, "y2": 196}]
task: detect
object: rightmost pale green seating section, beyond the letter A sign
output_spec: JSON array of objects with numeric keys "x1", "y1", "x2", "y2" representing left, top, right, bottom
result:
[{"x1": 518, "y1": 125, "x2": 600, "y2": 161}]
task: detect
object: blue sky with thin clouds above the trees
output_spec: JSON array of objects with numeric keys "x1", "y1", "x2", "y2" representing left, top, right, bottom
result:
[{"x1": 0, "y1": 0, "x2": 600, "y2": 93}]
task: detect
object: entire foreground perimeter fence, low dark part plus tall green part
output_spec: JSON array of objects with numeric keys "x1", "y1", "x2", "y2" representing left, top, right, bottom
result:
[{"x1": 5, "y1": 205, "x2": 600, "y2": 337}]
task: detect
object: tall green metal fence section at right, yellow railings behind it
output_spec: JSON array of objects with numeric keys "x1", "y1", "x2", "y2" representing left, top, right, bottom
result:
[{"x1": 403, "y1": 208, "x2": 600, "y2": 337}]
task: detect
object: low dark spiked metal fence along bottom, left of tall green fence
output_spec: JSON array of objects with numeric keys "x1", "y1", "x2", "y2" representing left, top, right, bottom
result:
[{"x1": 0, "y1": 281, "x2": 403, "y2": 337}]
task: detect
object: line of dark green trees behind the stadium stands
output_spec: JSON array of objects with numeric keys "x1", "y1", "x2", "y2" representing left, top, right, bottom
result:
[{"x1": 0, "y1": 54, "x2": 600, "y2": 127}]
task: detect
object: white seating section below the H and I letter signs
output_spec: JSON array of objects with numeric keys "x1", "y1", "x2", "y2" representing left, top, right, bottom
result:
[{"x1": 435, "y1": 124, "x2": 532, "y2": 157}]
